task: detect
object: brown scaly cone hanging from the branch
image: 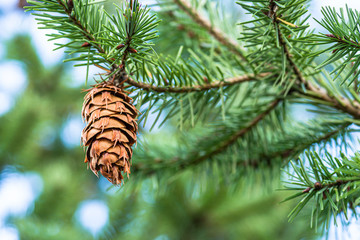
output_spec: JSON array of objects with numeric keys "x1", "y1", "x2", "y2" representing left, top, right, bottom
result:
[{"x1": 81, "y1": 83, "x2": 138, "y2": 185}]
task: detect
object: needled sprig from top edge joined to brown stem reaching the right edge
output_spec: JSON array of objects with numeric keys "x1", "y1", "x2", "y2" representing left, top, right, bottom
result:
[{"x1": 235, "y1": 0, "x2": 360, "y2": 122}]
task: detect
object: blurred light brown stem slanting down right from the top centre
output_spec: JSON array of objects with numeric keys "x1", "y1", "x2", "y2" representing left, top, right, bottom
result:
[{"x1": 173, "y1": 0, "x2": 247, "y2": 61}]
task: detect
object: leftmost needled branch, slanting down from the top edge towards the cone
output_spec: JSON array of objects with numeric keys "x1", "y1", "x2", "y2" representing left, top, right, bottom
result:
[{"x1": 26, "y1": 0, "x2": 110, "y2": 65}]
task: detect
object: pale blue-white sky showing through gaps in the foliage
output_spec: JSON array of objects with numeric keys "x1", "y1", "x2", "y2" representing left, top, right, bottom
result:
[{"x1": 0, "y1": 0, "x2": 360, "y2": 240}]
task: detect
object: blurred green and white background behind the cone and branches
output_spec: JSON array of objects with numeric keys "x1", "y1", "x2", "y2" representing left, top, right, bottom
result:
[{"x1": 0, "y1": 0, "x2": 360, "y2": 240}]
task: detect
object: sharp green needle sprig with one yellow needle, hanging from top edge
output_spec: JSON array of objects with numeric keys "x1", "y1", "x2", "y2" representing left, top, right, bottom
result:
[{"x1": 237, "y1": 0, "x2": 314, "y2": 87}]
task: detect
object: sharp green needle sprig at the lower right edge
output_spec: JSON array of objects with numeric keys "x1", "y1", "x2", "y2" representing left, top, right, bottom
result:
[{"x1": 286, "y1": 152, "x2": 360, "y2": 229}]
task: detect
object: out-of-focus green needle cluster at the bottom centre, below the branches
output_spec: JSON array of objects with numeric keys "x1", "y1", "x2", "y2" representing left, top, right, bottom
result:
[{"x1": 98, "y1": 171, "x2": 316, "y2": 239}]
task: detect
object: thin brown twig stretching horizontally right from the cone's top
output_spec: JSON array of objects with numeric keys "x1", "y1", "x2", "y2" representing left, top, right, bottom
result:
[{"x1": 127, "y1": 72, "x2": 271, "y2": 93}]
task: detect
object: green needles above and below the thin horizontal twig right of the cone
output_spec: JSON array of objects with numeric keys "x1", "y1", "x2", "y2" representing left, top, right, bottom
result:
[{"x1": 131, "y1": 48, "x2": 258, "y2": 126}]
